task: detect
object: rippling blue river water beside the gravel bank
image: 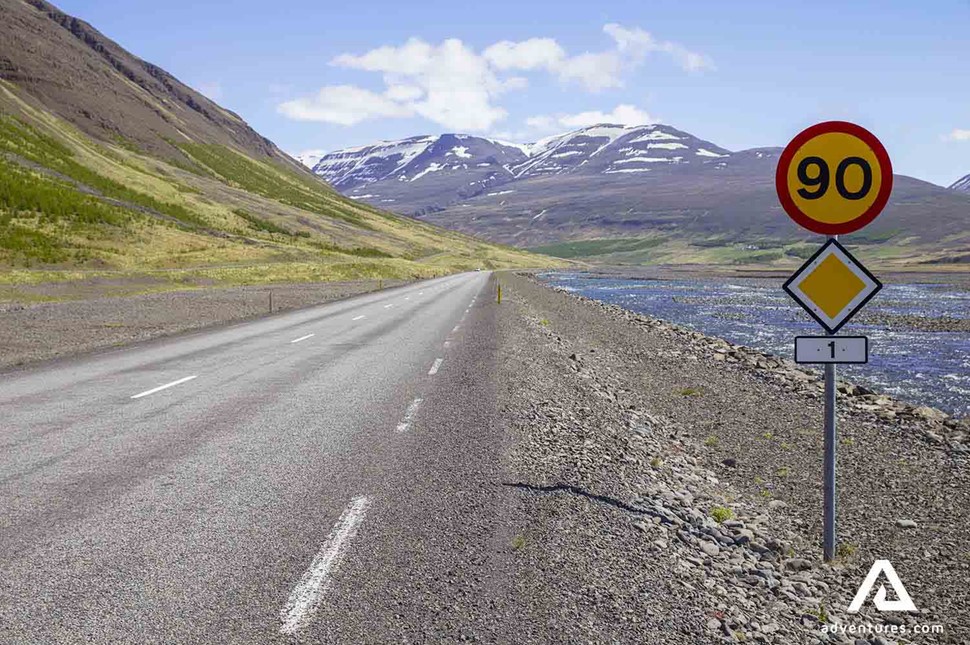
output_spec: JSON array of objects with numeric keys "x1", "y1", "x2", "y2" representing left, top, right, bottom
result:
[{"x1": 542, "y1": 273, "x2": 970, "y2": 417}]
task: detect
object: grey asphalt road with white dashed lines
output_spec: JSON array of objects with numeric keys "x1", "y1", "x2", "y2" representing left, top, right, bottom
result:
[{"x1": 0, "y1": 273, "x2": 510, "y2": 643}]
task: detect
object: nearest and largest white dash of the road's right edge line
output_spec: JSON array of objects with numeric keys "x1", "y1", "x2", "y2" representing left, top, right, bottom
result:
[{"x1": 280, "y1": 496, "x2": 370, "y2": 634}]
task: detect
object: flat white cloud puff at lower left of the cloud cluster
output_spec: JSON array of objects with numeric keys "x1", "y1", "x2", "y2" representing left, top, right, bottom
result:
[{"x1": 277, "y1": 85, "x2": 413, "y2": 125}]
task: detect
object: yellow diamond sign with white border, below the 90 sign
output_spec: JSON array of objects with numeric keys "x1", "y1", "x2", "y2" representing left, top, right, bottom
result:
[{"x1": 785, "y1": 239, "x2": 882, "y2": 334}]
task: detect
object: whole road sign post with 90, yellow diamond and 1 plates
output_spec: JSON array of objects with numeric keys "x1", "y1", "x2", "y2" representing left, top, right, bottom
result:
[{"x1": 775, "y1": 121, "x2": 893, "y2": 562}]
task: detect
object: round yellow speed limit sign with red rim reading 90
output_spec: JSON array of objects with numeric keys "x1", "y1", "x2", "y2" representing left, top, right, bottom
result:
[{"x1": 775, "y1": 121, "x2": 893, "y2": 235}]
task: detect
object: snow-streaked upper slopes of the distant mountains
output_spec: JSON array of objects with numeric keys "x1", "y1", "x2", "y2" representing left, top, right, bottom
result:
[{"x1": 313, "y1": 124, "x2": 731, "y2": 215}]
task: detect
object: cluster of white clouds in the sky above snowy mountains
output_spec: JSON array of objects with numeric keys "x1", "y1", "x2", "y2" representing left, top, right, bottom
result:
[{"x1": 278, "y1": 24, "x2": 710, "y2": 132}]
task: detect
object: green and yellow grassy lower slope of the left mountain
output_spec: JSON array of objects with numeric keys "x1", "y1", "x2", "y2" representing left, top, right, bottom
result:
[{"x1": 0, "y1": 81, "x2": 554, "y2": 298}]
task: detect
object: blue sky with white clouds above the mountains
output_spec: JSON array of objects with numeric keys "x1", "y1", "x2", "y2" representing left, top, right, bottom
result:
[{"x1": 57, "y1": 0, "x2": 970, "y2": 185}]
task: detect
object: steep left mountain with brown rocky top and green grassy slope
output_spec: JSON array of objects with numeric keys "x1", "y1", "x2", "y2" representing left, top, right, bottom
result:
[{"x1": 0, "y1": 0, "x2": 542, "y2": 284}]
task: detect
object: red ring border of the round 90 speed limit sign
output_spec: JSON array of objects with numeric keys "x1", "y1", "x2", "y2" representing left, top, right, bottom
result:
[{"x1": 775, "y1": 121, "x2": 893, "y2": 235}]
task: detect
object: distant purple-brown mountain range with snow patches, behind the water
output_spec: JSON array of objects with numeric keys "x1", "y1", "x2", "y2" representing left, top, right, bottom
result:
[{"x1": 315, "y1": 124, "x2": 970, "y2": 263}]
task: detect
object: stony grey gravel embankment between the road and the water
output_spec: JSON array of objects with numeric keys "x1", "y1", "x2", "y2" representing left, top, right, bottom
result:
[{"x1": 501, "y1": 275, "x2": 970, "y2": 645}]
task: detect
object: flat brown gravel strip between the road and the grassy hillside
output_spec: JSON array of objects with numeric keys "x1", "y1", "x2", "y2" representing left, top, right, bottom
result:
[{"x1": 0, "y1": 280, "x2": 405, "y2": 370}]
